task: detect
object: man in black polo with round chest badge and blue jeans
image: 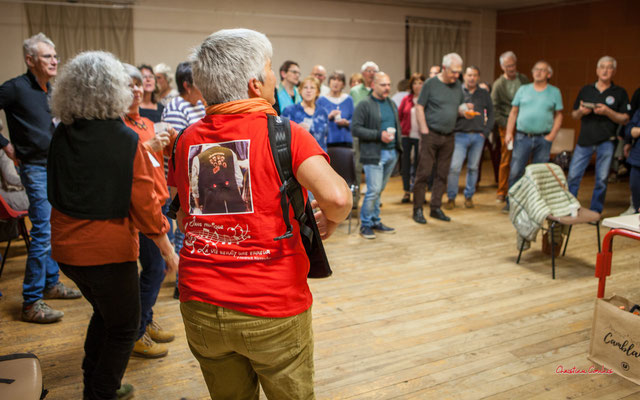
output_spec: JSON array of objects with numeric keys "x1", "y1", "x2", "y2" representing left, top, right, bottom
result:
[{"x1": 567, "y1": 56, "x2": 631, "y2": 213}]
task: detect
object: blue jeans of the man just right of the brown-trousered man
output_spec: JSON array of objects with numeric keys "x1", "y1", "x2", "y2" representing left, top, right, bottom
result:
[{"x1": 447, "y1": 132, "x2": 484, "y2": 200}]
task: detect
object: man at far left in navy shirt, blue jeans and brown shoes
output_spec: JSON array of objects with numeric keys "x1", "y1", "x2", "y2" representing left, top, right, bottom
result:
[{"x1": 0, "y1": 33, "x2": 81, "y2": 324}]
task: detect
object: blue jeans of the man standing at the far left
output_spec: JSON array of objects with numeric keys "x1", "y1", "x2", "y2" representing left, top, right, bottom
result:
[{"x1": 20, "y1": 164, "x2": 60, "y2": 304}]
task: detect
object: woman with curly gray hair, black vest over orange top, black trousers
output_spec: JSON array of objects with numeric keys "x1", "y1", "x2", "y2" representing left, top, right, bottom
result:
[{"x1": 47, "y1": 51, "x2": 178, "y2": 399}]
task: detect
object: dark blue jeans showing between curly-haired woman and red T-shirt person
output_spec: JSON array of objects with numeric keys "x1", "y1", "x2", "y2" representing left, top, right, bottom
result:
[{"x1": 138, "y1": 233, "x2": 166, "y2": 339}]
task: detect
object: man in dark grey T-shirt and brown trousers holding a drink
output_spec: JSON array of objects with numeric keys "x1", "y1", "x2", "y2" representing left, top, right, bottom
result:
[{"x1": 413, "y1": 53, "x2": 475, "y2": 224}]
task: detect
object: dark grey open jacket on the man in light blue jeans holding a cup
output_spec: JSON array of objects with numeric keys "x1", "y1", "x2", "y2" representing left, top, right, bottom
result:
[{"x1": 351, "y1": 95, "x2": 402, "y2": 164}]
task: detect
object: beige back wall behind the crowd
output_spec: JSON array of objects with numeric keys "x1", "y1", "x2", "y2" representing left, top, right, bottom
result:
[{"x1": 0, "y1": 0, "x2": 496, "y2": 133}]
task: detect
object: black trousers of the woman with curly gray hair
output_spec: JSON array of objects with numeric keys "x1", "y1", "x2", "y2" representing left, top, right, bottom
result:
[{"x1": 59, "y1": 261, "x2": 140, "y2": 400}]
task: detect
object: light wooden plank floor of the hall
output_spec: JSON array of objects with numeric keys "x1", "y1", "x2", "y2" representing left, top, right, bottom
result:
[{"x1": 0, "y1": 164, "x2": 640, "y2": 400}]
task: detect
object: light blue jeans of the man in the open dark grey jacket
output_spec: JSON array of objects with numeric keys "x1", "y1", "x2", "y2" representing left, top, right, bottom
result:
[{"x1": 360, "y1": 150, "x2": 398, "y2": 227}]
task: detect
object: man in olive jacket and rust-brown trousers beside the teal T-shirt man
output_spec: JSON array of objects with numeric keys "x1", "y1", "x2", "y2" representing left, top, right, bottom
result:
[{"x1": 491, "y1": 51, "x2": 529, "y2": 202}]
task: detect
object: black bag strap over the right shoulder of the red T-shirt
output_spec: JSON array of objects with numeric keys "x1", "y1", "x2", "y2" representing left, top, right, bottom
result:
[{"x1": 267, "y1": 115, "x2": 313, "y2": 242}]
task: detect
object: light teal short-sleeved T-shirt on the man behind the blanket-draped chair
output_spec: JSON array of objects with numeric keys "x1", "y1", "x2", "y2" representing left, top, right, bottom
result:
[{"x1": 511, "y1": 83, "x2": 562, "y2": 134}]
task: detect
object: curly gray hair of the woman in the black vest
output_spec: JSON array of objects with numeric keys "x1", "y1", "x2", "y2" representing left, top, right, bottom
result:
[{"x1": 51, "y1": 51, "x2": 133, "y2": 125}]
